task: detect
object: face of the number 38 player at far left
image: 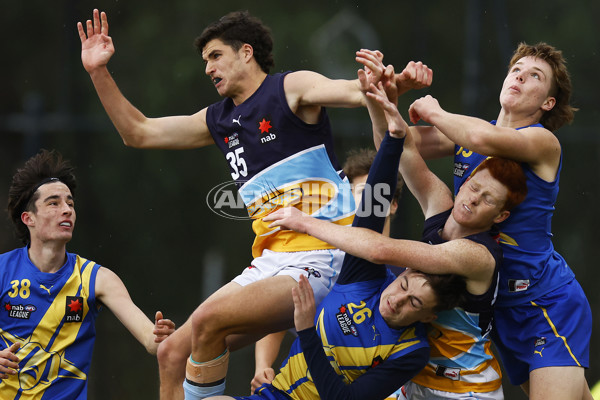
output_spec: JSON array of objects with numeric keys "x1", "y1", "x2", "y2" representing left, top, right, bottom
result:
[{"x1": 22, "y1": 182, "x2": 76, "y2": 243}]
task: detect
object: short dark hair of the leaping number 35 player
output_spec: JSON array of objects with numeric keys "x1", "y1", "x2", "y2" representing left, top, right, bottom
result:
[{"x1": 194, "y1": 11, "x2": 275, "y2": 74}]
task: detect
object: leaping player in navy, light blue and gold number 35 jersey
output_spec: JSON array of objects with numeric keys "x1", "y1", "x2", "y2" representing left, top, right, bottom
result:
[{"x1": 78, "y1": 10, "x2": 432, "y2": 400}]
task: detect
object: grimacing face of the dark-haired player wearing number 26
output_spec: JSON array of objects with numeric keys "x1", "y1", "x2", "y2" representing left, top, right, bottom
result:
[{"x1": 379, "y1": 269, "x2": 437, "y2": 328}]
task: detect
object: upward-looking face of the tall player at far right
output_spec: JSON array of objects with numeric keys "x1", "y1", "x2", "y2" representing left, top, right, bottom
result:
[{"x1": 500, "y1": 56, "x2": 555, "y2": 114}]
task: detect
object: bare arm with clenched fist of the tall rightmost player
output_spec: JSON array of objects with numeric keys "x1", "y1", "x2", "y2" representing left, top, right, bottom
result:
[{"x1": 409, "y1": 96, "x2": 561, "y2": 181}]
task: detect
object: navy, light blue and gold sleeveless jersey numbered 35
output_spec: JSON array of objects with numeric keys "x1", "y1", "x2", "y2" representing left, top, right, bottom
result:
[{"x1": 206, "y1": 73, "x2": 355, "y2": 257}]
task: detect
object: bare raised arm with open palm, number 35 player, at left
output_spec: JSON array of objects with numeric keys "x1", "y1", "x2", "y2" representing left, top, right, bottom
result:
[{"x1": 77, "y1": 10, "x2": 214, "y2": 149}]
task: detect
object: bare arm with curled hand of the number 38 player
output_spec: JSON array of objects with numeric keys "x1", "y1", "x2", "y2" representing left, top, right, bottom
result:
[{"x1": 96, "y1": 267, "x2": 175, "y2": 354}]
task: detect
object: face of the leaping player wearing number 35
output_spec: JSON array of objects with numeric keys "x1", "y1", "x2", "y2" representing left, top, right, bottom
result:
[{"x1": 202, "y1": 39, "x2": 244, "y2": 97}]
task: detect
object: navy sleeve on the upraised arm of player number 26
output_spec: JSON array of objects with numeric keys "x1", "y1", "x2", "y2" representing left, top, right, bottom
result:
[{"x1": 337, "y1": 132, "x2": 404, "y2": 284}]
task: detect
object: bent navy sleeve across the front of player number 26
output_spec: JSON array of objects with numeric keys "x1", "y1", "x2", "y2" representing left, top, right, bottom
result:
[{"x1": 298, "y1": 327, "x2": 429, "y2": 400}]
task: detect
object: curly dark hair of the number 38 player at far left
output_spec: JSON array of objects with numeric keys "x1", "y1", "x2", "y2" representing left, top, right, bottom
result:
[{"x1": 6, "y1": 149, "x2": 77, "y2": 244}]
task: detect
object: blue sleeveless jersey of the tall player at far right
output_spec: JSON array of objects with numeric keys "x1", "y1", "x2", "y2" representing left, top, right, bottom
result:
[{"x1": 454, "y1": 121, "x2": 575, "y2": 307}]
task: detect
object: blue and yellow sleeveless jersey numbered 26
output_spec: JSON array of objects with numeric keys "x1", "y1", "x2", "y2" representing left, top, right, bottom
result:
[{"x1": 272, "y1": 274, "x2": 427, "y2": 400}]
